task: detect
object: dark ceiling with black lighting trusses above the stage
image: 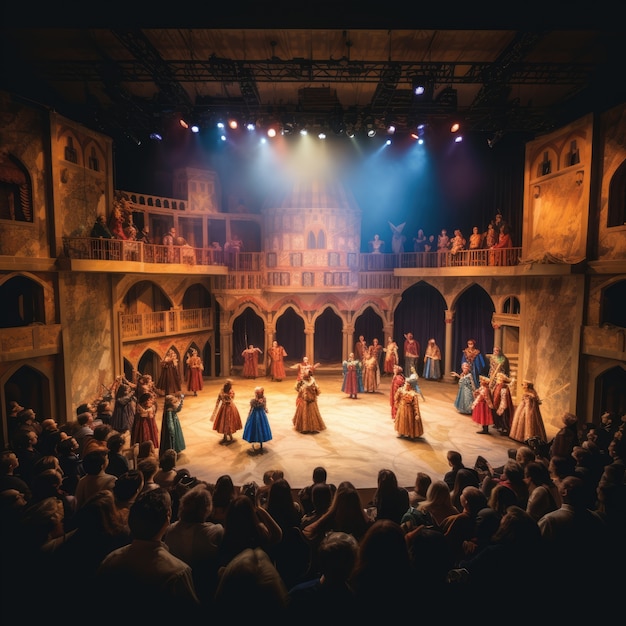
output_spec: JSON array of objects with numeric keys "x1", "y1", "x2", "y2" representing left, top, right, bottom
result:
[{"x1": 0, "y1": 16, "x2": 626, "y2": 147}]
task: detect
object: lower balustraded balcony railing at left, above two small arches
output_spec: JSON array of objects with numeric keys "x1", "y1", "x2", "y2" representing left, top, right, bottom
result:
[{"x1": 120, "y1": 308, "x2": 213, "y2": 340}]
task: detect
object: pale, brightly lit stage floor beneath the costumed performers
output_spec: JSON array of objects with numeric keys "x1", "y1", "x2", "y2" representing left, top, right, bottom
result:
[{"x1": 172, "y1": 371, "x2": 519, "y2": 489}]
